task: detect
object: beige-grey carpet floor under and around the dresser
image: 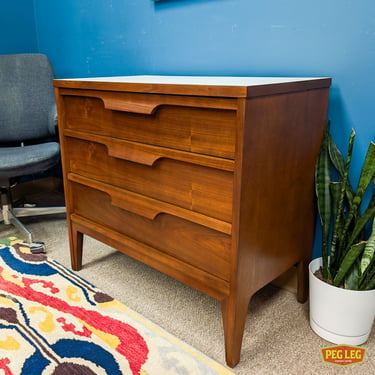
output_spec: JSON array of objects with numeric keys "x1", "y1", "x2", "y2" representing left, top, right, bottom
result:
[{"x1": 0, "y1": 216, "x2": 375, "y2": 375}]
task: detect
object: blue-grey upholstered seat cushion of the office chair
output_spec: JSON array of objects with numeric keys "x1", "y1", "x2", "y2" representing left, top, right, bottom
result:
[{"x1": 0, "y1": 142, "x2": 60, "y2": 178}]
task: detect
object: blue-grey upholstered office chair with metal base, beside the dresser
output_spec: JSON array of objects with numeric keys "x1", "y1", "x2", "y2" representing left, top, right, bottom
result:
[{"x1": 0, "y1": 54, "x2": 65, "y2": 242}]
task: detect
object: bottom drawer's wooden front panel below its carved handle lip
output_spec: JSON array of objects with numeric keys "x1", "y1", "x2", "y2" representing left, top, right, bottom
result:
[{"x1": 71, "y1": 183, "x2": 231, "y2": 280}]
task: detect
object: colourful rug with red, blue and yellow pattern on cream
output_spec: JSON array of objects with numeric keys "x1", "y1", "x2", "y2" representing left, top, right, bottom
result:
[{"x1": 0, "y1": 238, "x2": 233, "y2": 375}]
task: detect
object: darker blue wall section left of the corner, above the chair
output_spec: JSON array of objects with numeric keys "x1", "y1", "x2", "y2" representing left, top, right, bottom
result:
[{"x1": 0, "y1": 0, "x2": 38, "y2": 54}]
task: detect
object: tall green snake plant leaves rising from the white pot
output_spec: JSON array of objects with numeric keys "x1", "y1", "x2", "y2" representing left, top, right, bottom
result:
[{"x1": 315, "y1": 124, "x2": 375, "y2": 290}]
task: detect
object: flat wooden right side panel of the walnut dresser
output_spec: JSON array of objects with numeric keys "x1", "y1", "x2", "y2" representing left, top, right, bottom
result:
[{"x1": 234, "y1": 89, "x2": 328, "y2": 290}]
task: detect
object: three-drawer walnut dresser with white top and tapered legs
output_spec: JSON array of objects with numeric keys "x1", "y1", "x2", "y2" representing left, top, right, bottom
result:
[{"x1": 54, "y1": 76, "x2": 331, "y2": 367}]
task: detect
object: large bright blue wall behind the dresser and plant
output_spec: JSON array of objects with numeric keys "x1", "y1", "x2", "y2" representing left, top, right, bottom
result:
[{"x1": 8, "y1": 0, "x2": 375, "y2": 258}]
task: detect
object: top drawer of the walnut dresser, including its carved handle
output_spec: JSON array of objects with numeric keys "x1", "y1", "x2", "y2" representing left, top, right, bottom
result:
[{"x1": 60, "y1": 89, "x2": 237, "y2": 159}]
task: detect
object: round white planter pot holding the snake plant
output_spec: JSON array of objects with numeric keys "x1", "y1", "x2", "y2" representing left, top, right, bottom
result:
[{"x1": 309, "y1": 258, "x2": 375, "y2": 345}]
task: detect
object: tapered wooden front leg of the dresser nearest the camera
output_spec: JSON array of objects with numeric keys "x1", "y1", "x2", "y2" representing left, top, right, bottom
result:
[{"x1": 221, "y1": 295, "x2": 250, "y2": 367}]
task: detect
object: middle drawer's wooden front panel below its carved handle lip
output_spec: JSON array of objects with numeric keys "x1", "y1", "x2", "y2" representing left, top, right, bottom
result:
[{"x1": 65, "y1": 137, "x2": 233, "y2": 223}]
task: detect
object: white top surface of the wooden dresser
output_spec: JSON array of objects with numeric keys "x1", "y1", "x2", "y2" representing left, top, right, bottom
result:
[{"x1": 57, "y1": 75, "x2": 328, "y2": 86}]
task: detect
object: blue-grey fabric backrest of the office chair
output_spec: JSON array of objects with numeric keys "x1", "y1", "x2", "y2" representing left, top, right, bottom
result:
[{"x1": 0, "y1": 54, "x2": 56, "y2": 143}]
